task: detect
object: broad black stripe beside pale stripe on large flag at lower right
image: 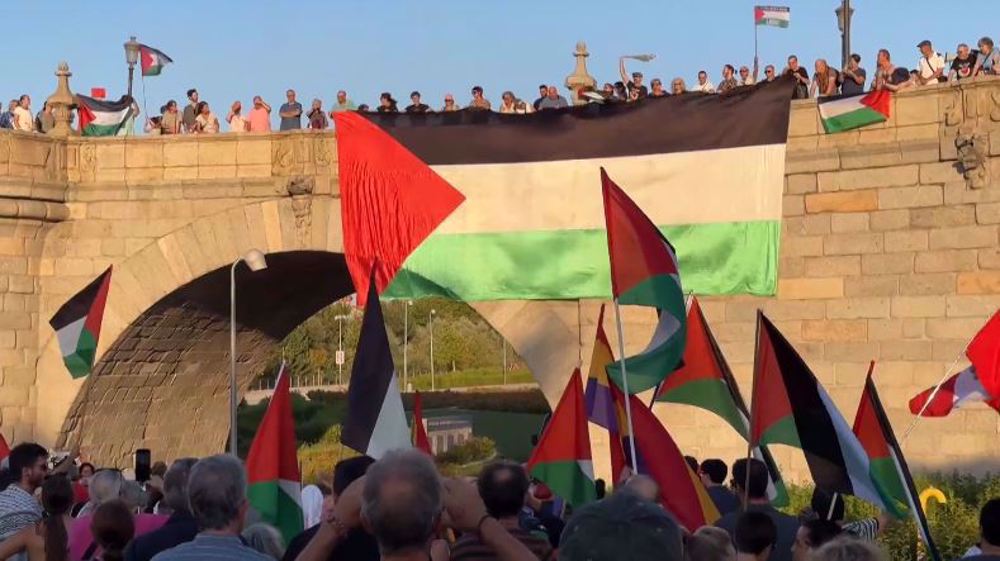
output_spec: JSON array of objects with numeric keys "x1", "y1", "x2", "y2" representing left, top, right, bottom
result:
[{"x1": 760, "y1": 314, "x2": 854, "y2": 495}]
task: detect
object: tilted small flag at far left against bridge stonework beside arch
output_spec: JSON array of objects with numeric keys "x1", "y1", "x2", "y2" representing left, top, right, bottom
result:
[{"x1": 49, "y1": 267, "x2": 111, "y2": 378}]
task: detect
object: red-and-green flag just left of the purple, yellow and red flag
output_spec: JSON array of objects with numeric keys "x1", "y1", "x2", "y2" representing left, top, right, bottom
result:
[{"x1": 528, "y1": 368, "x2": 597, "y2": 508}]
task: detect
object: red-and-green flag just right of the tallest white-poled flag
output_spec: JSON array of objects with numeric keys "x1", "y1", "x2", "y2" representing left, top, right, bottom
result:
[{"x1": 655, "y1": 297, "x2": 788, "y2": 507}]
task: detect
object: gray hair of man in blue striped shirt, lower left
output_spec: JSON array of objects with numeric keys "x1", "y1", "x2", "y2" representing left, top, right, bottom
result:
[{"x1": 188, "y1": 454, "x2": 247, "y2": 530}]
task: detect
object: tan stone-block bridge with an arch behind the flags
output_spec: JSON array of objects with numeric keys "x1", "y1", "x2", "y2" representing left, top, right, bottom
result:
[{"x1": 0, "y1": 70, "x2": 1000, "y2": 477}]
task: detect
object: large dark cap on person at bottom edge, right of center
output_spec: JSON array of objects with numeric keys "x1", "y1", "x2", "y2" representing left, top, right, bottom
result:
[{"x1": 559, "y1": 493, "x2": 684, "y2": 561}]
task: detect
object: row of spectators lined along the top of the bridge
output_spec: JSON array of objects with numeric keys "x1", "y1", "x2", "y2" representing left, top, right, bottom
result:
[{"x1": 0, "y1": 37, "x2": 1000, "y2": 134}]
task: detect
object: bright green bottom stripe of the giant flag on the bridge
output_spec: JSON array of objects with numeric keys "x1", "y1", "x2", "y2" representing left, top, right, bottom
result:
[{"x1": 382, "y1": 220, "x2": 781, "y2": 300}]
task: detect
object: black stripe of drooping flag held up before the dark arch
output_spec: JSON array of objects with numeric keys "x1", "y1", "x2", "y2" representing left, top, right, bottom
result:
[{"x1": 340, "y1": 267, "x2": 396, "y2": 454}]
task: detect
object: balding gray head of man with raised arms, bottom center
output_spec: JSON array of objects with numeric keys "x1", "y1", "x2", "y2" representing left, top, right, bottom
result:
[{"x1": 361, "y1": 449, "x2": 444, "y2": 556}]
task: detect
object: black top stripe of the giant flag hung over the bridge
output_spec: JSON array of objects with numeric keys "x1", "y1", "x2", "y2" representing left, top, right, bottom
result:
[{"x1": 356, "y1": 77, "x2": 793, "y2": 165}]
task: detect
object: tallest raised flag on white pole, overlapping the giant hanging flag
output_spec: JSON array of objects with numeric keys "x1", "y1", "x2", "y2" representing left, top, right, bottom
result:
[{"x1": 601, "y1": 168, "x2": 687, "y2": 394}]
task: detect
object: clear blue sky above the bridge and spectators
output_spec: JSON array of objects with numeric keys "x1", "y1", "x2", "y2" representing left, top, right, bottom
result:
[{"x1": 0, "y1": 0, "x2": 1000, "y2": 116}]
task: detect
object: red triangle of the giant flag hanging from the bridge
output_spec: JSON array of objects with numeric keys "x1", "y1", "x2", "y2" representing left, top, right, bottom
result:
[{"x1": 334, "y1": 111, "x2": 465, "y2": 306}]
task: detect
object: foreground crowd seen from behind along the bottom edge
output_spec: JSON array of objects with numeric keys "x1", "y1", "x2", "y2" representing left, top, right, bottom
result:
[{"x1": 0, "y1": 443, "x2": 1000, "y2": 561}]
